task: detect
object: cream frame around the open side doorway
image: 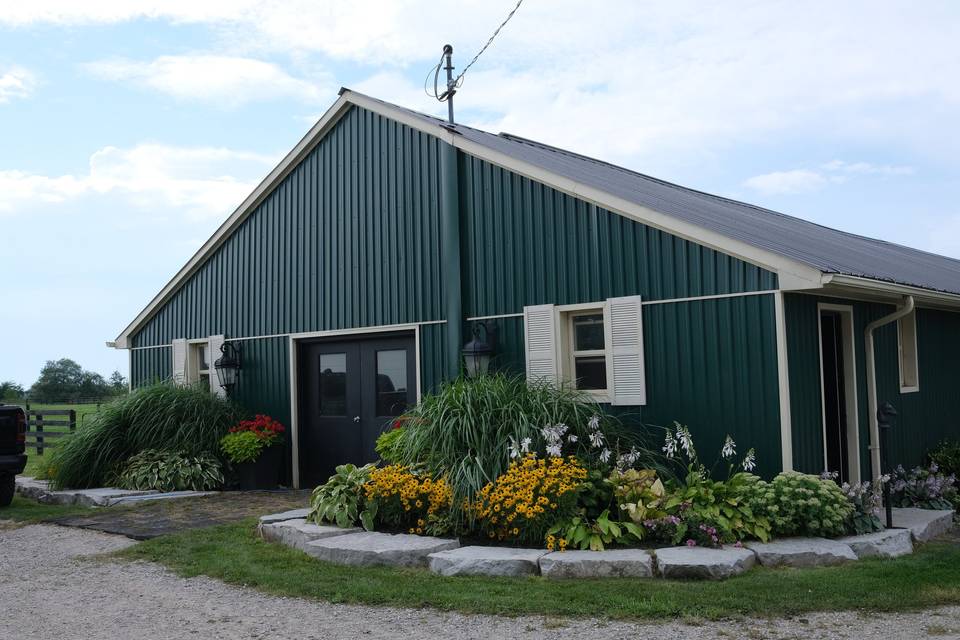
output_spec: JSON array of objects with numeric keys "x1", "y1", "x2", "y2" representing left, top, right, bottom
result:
[{"x1": 817, "y1": 302, "x2": 861, "y2": 483}]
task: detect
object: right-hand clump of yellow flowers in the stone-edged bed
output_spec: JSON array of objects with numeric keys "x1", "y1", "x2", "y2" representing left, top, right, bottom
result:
[{"x1": 472, "y1": 454, "x2": 587, "y2": 544}]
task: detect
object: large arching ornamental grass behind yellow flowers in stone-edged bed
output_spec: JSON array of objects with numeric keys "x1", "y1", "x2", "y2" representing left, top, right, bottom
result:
[{"x1": 397, "y1": 374, "x2": 639, "y2": 517}]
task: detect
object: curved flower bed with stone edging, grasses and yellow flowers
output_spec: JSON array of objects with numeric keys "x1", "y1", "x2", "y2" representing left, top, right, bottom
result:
[{"x1": 286, "y1": 375, "x2": 957, "y2": 579}]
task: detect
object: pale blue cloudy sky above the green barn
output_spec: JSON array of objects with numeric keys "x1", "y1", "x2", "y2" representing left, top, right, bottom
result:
[{"x1": 0, "y1": 0, "x2": 960, "y2": 386}]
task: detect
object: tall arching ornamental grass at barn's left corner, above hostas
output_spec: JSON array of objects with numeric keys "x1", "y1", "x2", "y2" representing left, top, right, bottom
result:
[{"x1": 51, "y1": 383, "x2": 243, "y2": 489}]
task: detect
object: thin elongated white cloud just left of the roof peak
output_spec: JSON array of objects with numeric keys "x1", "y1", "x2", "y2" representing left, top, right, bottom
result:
[{"x1": 84, "y1": 55, "x2": 333, "y2": 106}]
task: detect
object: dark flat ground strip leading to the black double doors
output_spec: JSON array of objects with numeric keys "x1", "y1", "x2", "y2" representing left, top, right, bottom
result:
[{"x1": 49, "y1": 490, "x2": 310, "y2": 540}]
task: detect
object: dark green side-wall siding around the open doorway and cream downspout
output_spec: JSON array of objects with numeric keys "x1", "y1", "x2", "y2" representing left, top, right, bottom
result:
[{"x1": 785, "y1": 294, "x2": 960, "y2": 478}]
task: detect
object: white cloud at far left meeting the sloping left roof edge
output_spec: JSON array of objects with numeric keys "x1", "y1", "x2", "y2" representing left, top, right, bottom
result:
[{"x1": 0, "y1": 144, "x2": 278, "y2": 217}]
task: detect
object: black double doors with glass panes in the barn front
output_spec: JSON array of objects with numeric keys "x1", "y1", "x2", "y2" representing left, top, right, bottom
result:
[{"x1": 298, "y1": 335, "x2": 417, "y2": 487}]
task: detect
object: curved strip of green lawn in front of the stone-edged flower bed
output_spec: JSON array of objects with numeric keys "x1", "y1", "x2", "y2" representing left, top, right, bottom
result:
[{"x1": 118, "y1": 520, "x2": 960, "y2": 618}]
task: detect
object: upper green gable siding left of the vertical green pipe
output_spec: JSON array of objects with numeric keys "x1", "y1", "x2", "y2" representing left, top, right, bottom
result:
[{"x1": 133, "y1": 107, "x2": 443, "y2": 346}]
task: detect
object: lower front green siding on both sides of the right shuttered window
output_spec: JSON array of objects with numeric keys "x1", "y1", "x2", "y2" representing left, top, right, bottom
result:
[{"x1": 495, "y1": 294, "x2": 781, "y2": 476}]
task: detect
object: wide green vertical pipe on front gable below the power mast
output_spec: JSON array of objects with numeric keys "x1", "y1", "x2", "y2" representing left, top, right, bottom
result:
[{"x1": 440, "y1": 142, "x2": 463, "y2": 380}]
